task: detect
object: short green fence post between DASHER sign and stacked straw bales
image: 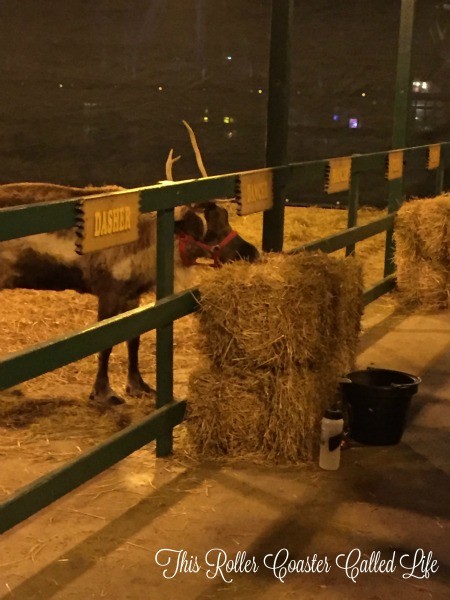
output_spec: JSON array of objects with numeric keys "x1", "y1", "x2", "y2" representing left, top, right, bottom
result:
[{"x1": 156, "y1": 208, "x2": 175, "y2": 457}]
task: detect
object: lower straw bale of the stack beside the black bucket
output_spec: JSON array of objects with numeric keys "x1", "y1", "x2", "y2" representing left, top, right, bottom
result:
[{"x1": 186, "y1": 363, "x2": 337, "y2": 464}]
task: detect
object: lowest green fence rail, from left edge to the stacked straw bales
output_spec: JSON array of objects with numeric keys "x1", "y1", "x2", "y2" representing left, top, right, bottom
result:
[{"x1": 0, "y1": 401, "x2": 186, "y2": 533}]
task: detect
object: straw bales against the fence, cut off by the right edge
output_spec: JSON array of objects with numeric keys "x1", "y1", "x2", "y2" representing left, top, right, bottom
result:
[{"x1": 394, "y1": 194, "x2": 450, "y2": 310}]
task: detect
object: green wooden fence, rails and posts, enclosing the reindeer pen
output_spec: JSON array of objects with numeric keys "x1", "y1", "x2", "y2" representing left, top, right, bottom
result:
[{"x1": 0, "y1": 143, "x2": 450, "y2": 532}]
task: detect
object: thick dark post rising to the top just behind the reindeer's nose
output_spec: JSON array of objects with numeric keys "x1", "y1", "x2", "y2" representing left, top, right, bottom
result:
[{"x1": 262, "y1": 0, "x2": 294, "y2": 252}]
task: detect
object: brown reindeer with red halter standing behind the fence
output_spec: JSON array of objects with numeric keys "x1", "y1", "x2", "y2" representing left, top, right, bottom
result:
[{"x1": 0, "y1": 127, "x2": 258, "y2": 405}]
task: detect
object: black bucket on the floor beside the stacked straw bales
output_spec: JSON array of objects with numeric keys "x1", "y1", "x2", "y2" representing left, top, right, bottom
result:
[{"x1": 342, "y1": 368, "x2": 420, "y2": 446}]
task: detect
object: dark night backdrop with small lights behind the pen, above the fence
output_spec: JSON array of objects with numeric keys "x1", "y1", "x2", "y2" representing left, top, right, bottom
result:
[{"x1": 0, "y1": 0, "x2": 450, "y2": 201}]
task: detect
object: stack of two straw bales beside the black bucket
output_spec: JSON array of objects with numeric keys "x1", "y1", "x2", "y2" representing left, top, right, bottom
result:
[{"x1": 187, "y1": 252, "x2": 362, "y2": 463}]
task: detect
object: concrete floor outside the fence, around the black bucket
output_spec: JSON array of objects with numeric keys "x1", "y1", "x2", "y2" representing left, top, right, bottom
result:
[{"x1": 0, "y1": 303, "x2": 450, "y2": 600}]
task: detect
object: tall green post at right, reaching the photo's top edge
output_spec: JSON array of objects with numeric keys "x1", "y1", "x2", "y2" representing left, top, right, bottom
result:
[{"x1": 384, "y1": 0, "x2": 416, "y2": 276}]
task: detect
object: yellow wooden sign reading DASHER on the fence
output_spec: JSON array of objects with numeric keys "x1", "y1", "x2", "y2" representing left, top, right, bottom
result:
[{"x1": 77, "y1": 192, "x2": 139, "y2": 254}]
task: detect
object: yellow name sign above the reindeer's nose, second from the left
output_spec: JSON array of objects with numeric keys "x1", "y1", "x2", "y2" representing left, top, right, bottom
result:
[{"x1": 236, "y1": 169, "x2": 273, "y2": 217}]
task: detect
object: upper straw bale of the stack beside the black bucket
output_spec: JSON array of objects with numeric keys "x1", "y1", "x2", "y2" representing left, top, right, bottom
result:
[{"x1": 200, "y1": 252, "x2": 362, "y2": 369}]
